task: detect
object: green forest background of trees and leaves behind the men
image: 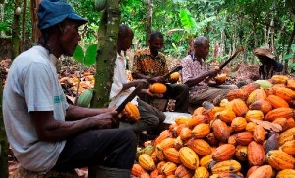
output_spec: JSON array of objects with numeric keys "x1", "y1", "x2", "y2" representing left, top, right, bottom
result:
[{"x1": 0, "y1": 0, "x2": 295, "y2": 176}]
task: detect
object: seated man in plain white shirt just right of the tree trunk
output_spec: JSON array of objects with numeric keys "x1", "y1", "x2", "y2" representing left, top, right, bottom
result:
[{"x1": 109, "y1": 25, "x2": 165, "y2": 132}]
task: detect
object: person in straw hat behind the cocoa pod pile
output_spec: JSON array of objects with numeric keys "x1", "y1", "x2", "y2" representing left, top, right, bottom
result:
[{"x1": 254, "y1": 46, "x2": 283, "y2": 80}]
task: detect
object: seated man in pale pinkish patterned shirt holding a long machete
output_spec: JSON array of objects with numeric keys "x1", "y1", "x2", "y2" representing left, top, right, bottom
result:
[{"x1": 181, "y1": 36, "x2": 237, "y2": 106}]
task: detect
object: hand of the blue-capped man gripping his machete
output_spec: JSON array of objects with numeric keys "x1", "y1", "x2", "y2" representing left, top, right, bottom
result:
[{"x1": 91, "y1": 111, "x2": 118, "y2": 129}]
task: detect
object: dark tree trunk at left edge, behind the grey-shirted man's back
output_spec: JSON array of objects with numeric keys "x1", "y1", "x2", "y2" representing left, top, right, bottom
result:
[{"x1": 0, "y1": 68, "x2": 9, "y2": 177}]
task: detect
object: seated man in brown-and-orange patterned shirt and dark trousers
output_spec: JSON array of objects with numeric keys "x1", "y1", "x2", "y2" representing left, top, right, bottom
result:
[{"x1": 132, "y1": 31, "x2": 189, "y2": 113}]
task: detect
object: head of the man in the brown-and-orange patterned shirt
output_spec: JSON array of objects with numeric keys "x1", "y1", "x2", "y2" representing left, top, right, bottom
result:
[{"x1": 148, "y1": 31, "x2": 164, "y2": 55}]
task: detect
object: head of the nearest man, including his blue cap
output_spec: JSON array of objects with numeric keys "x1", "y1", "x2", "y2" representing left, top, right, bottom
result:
[{"x1": 38, "y1": 0, "x2": 87, "y2": 57}]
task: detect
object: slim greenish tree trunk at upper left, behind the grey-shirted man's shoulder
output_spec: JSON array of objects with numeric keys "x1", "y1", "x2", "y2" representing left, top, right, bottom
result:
[{"x1": 11, "y1": 0, "x2": 24, "y2": 59}]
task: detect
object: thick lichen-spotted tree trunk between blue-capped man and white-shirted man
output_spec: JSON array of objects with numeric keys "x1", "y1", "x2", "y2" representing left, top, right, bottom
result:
[{"x1": 91, "y1": 0, "x2": 121, "y2": 108}]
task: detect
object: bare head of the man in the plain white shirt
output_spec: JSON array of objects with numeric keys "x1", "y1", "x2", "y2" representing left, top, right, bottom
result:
[{"x1": 117, "y1": 24, "x2": 134, "y2": 52}]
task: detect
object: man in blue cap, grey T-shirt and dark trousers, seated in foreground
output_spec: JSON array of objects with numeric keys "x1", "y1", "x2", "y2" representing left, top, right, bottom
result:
[{"x1": 3, "y1": 0, "x2": 137, "y2": 178}]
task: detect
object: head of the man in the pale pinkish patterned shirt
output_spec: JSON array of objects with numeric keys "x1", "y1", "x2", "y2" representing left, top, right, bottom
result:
[{"x1": 194, "y1": 36, "x2": 209, "y2": 59}]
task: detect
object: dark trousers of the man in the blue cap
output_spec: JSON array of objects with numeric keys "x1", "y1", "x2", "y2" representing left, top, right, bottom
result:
[{"x1": 53, "y1": 129, "x2": 137, "y2": 170}]
